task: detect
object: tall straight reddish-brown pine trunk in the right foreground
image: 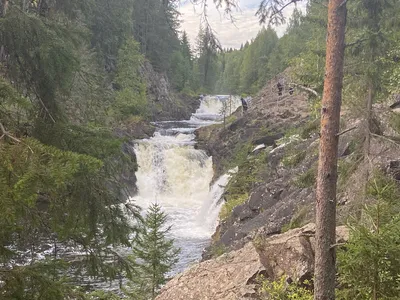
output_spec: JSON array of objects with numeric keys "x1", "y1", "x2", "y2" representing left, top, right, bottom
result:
[{"x1": 314, "y1": 0, "x2": 347, "y2": 300}]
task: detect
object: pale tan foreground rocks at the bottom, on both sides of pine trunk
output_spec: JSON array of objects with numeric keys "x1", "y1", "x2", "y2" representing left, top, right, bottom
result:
[{"x1": 156, "y1": 224, "x2": 348, "y2": 300}]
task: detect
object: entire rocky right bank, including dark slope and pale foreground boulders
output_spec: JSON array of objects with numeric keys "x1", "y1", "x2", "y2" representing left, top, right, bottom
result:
[{"x1": 157, "y1": 74, "x2": 400, "y2": 300}]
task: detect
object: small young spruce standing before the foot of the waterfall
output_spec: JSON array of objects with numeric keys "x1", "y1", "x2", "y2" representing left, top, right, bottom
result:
[{"x1": 126, "y1": 204, "x2": 180, "y2": 300}]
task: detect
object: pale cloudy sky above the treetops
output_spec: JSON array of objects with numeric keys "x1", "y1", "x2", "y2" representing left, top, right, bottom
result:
[{"x1": 179, "y1": 0, "x2": 304, "y2": 48}]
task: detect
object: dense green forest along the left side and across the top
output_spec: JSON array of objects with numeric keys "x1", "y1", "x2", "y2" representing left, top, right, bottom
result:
[{"x1": 0, "y1": 0, "x2": 400, "y2": 299}]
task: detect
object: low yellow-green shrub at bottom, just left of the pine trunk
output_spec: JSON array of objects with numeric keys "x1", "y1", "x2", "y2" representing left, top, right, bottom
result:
[{"x1": 259, "y1": 276, "x2": 313, "y2": 300}]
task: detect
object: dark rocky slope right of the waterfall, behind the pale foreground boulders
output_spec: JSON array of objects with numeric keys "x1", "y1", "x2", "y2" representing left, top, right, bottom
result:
[{"x1": 196, "y1": 77, "x2": 400, "y2": 260}]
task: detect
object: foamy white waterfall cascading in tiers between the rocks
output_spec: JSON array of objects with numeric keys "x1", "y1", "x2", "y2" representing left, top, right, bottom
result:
[{"x1": 132, "y1": 96, "x2": 241, "y2": 272}]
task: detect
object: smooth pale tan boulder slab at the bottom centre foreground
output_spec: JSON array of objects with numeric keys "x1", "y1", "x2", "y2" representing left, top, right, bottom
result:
[{"x1": 156, "y1": 243, "x2": 265, "y2": 300}]
